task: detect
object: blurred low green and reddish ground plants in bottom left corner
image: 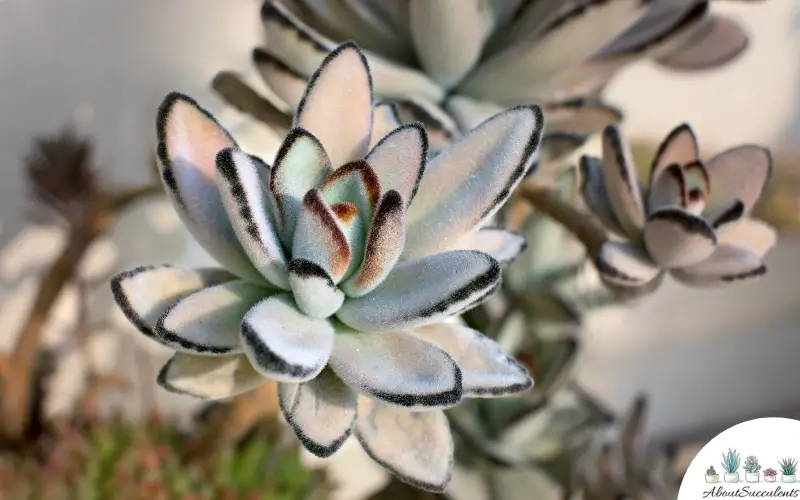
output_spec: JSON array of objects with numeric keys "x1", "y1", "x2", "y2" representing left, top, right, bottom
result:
[{"x1": 0, "y1": 404, "x2": 326, "y2": 500}]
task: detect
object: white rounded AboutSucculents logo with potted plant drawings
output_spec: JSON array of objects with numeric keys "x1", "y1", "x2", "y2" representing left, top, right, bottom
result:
[{"x1": 678, "y1": 418, "x2": 800, "y2": 500}]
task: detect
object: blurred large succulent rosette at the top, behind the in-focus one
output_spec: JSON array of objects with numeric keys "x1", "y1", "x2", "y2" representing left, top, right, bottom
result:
[{"x1": 253, "y1": 0, "x2": 748, "y2": 162}]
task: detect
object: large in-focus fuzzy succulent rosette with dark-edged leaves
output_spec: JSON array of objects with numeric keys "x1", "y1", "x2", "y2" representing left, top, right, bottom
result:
[{"x1": 112, "y1": 43, "x2": 543, "y2": 491}]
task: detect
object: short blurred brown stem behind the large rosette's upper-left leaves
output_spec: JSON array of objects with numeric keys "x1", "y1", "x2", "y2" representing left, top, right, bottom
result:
[{"x1": 211, "y1": 71, "x2": 292, "y2": 134}]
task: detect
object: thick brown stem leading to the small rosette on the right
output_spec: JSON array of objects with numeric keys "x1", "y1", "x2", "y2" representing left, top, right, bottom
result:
[{"x1": 517, "y1": 181, "x2": 607, "y2": 256}]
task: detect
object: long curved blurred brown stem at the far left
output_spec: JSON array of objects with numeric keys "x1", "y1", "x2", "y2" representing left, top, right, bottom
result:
[{"x1": 0, "y1": 186, "x2": 162, "y2": 443}]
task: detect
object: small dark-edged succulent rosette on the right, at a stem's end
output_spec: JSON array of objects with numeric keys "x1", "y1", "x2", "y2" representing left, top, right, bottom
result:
[{"x1": 580, "y1": 125, "x2": 776, "y2": 287}]
